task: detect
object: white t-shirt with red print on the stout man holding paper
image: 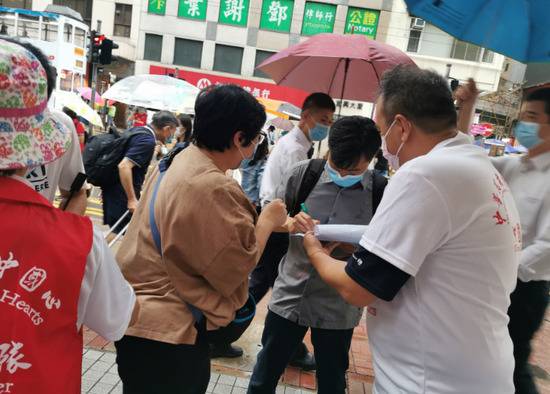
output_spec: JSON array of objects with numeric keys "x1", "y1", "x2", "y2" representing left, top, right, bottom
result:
[{"x1": 361, "y1": 134, "x2": 521, "y2": 394}]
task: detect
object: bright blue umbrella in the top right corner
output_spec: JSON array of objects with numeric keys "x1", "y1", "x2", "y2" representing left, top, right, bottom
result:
[{"x1": 405, "y1": 0, "x2": 550, "y2": 63}]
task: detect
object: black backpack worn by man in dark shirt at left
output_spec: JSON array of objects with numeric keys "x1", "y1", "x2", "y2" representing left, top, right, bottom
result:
[{"x1": 82, "y1": 127, "x2": 152, "y2": 187}]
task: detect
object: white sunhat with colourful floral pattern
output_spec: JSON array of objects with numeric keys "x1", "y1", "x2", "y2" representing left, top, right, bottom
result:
[{"x1": 0, "y1": 39, "x2": 71, "y2": 170}]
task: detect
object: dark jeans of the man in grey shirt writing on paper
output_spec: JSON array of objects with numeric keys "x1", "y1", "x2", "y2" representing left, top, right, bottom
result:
[{"x1": 248, "y1": 311, "x2": 353, "y2": 394}]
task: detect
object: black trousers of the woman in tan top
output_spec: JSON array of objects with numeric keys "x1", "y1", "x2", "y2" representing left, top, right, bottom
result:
[{"x1": 115, "y1": 336, "x2": 210, "y2": 394}]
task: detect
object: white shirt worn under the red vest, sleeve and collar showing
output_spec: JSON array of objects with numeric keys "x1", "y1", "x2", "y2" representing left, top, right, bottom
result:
[{"x1": 12, "y1": 175, "x2": 136, "y2": 341}]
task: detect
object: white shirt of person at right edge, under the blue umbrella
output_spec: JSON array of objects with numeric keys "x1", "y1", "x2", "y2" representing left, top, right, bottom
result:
[{"x1": 493, "y1": 152, "x2": 550, "y2": 282}]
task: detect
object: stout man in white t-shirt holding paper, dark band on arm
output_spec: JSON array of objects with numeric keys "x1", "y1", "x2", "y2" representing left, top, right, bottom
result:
[{"x1": 304, "y1": 66, "x2": 521, "y2": 394}]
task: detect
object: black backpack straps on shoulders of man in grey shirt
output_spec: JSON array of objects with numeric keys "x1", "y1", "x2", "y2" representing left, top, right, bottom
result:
[{"x1": 286, "y1": 159, "x2": 388, "y2": 217}]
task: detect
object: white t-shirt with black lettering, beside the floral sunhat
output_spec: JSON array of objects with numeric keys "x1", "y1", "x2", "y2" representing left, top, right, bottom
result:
[{"x1": 27, "y1": 109, "x2": 84, "y2": 202}]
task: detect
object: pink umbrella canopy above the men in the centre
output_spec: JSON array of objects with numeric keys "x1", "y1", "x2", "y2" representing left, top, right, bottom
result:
[{"x1": 258, "y1": 34, "x2": 415, "y2": 102}]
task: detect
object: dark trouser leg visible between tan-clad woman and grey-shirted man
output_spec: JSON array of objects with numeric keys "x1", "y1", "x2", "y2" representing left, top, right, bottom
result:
[{"x1": 248, "y1": 233, "x2": 288, "y2": 303}]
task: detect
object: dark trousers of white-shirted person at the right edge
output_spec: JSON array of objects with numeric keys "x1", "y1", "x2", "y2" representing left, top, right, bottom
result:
[{"x1": 508, "y1": 280, "x2": 549, "y2": 394}]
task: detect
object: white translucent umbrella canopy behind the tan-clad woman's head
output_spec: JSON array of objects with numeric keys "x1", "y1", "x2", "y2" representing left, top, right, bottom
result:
[{"x1": 103, "y1": 74, "x2": 200, "y2": 113}]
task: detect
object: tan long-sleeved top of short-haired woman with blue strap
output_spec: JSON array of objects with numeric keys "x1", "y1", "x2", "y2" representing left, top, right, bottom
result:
[{"x1": 116, "y1": 145, "x2": 259, "y2": 344}]
